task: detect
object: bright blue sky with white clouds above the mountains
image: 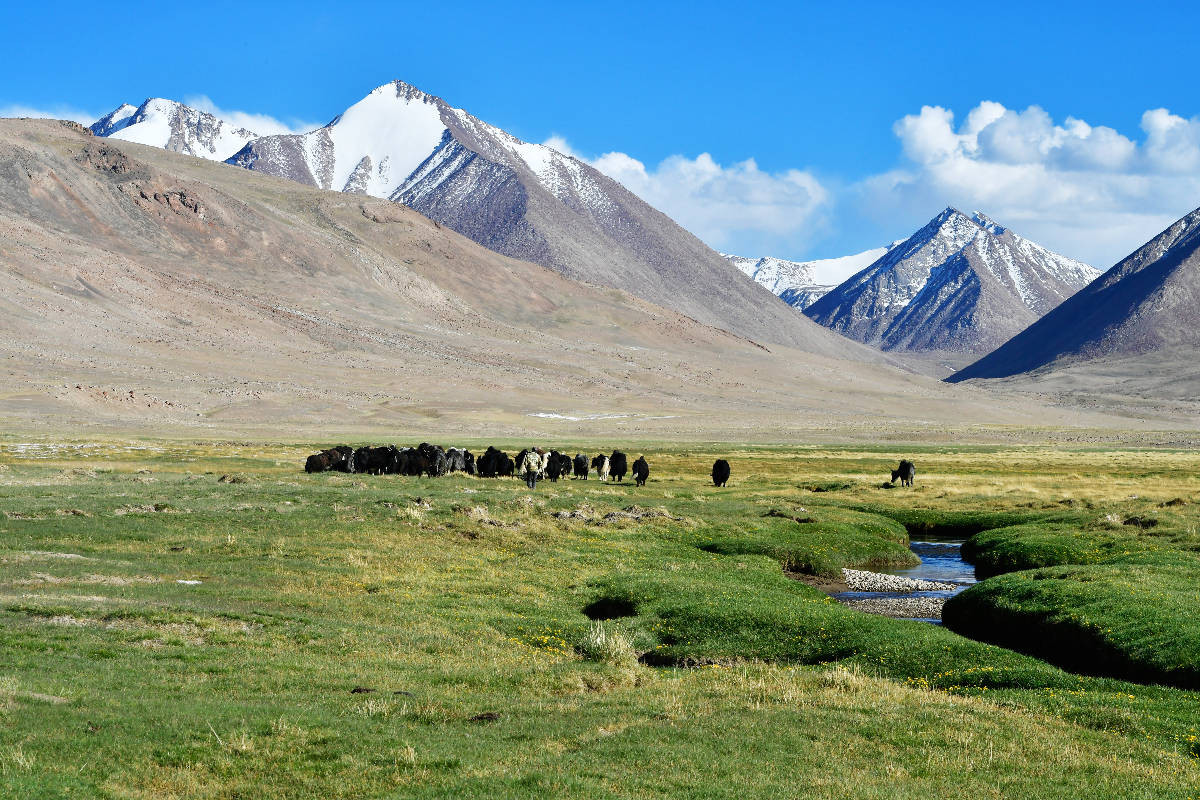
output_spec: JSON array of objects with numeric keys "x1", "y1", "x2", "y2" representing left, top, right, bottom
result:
[{"x1": 0, "y1": 0, "x2": 1200, "y2": 266}]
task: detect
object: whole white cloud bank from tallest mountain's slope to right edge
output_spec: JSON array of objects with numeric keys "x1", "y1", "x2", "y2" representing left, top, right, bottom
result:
[{"x1": 546, "y1": 101, "x2": 1200, "y2": 267}]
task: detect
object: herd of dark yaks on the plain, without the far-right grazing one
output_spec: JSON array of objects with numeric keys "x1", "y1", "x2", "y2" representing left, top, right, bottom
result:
[{"x1": 304, "y1": 441, "x2": 730, "y2": 486}]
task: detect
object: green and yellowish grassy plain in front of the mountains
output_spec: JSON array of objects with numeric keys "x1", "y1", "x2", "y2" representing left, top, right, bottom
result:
[{"x1": 0, "y1": 439, "x2": 1200, "y2": 799}]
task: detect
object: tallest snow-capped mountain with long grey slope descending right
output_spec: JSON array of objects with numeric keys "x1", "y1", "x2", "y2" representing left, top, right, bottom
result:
[{"x1": 87, "y1": 80, "x2": 854, "y2": 360}]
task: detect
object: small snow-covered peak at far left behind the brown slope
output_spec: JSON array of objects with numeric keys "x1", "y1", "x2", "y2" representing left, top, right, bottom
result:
[{"x1": 91, "y1": 97, "x2": 258, "y2": 161}]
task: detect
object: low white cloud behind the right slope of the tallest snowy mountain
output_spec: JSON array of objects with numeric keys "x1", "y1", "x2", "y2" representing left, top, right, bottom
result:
[{"x1": 545, "y1": 136, "x2": 830, "y2": 255}]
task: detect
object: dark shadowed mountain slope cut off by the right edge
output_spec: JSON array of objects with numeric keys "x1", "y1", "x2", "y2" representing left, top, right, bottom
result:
[{"x1": 948, "y1": 203, "x2": 1200, "y2": 399}]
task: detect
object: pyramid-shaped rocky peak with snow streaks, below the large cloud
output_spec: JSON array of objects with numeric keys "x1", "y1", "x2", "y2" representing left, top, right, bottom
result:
[{"x1": 804, "y1": 209, "x2": 1098, "y2": 359}]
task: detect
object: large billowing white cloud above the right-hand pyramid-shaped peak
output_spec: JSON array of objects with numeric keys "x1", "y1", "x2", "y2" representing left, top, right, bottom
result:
[{"x1": 856, "y1": 102, "x2": 1200, "y2": 269}]
